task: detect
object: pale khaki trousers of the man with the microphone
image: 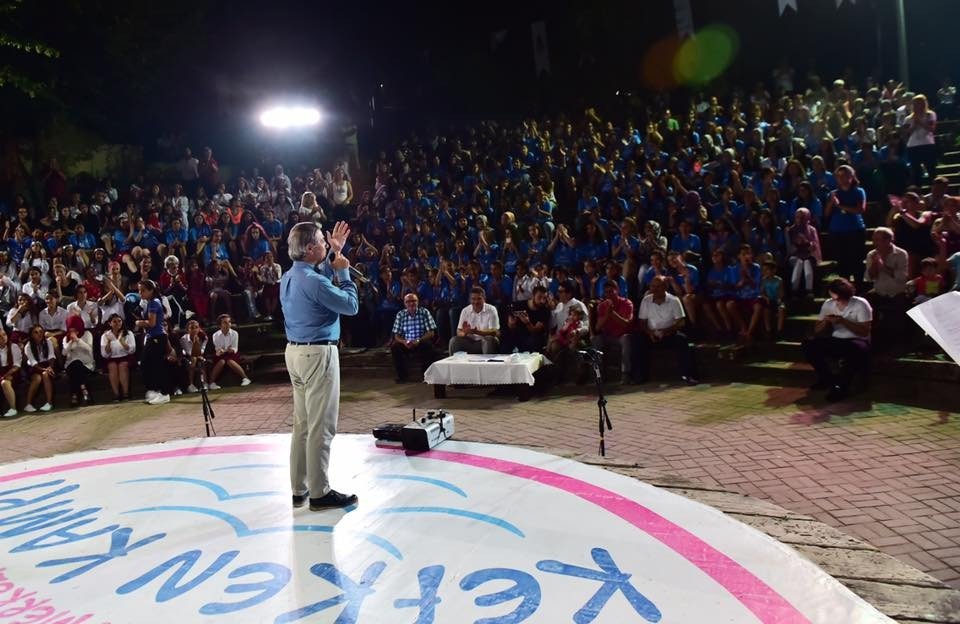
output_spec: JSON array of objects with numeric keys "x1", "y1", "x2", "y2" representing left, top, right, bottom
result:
[{"x1": 284, "y1": 344, "x2": 340, "y2": 498}]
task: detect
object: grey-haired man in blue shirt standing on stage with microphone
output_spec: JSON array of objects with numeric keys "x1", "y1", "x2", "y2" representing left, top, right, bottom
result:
[{"x1": 280, "y1": 221, "x2": 359, "y2": 511}]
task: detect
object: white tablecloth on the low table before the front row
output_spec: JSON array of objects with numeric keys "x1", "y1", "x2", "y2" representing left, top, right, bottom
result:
[{"x1": 423, "y1": 353, "x2": 550, "y2": 386}]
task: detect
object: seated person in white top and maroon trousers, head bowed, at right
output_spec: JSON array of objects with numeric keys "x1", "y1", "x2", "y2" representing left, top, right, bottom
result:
[{"x1": 803, "y1": 278, "x2": 873, "y2": 401}]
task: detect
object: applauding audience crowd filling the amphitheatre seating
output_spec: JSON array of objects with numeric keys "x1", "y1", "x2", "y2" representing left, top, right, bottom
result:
[{"x1": 0, "y1": 77, "x2": 960, "y2": 415}]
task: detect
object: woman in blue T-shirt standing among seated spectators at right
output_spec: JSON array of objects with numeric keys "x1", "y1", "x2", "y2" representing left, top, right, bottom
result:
[{"x1": 824, "y1": 165, "x2": 867, "y2": 285}]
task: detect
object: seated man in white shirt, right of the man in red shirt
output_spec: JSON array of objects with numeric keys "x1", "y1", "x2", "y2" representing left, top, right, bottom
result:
[{"x1": 633, "y1": 275, "x2": 700, "y2": 386}]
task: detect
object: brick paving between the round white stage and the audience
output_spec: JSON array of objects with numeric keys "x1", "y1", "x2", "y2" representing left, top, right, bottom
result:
[{"x1": 0, "y1": 371, "x2": 960, "y2": 588}]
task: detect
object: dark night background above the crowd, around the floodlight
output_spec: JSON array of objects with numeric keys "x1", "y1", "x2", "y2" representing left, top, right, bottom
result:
[{"x1": 0, "y1": 0, "x2": 960, "y2": 161}]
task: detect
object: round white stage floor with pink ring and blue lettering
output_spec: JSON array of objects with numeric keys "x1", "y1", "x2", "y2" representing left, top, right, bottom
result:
[{"x1": 0, "y1": 435, "x2": 891, "y2": 624}]
